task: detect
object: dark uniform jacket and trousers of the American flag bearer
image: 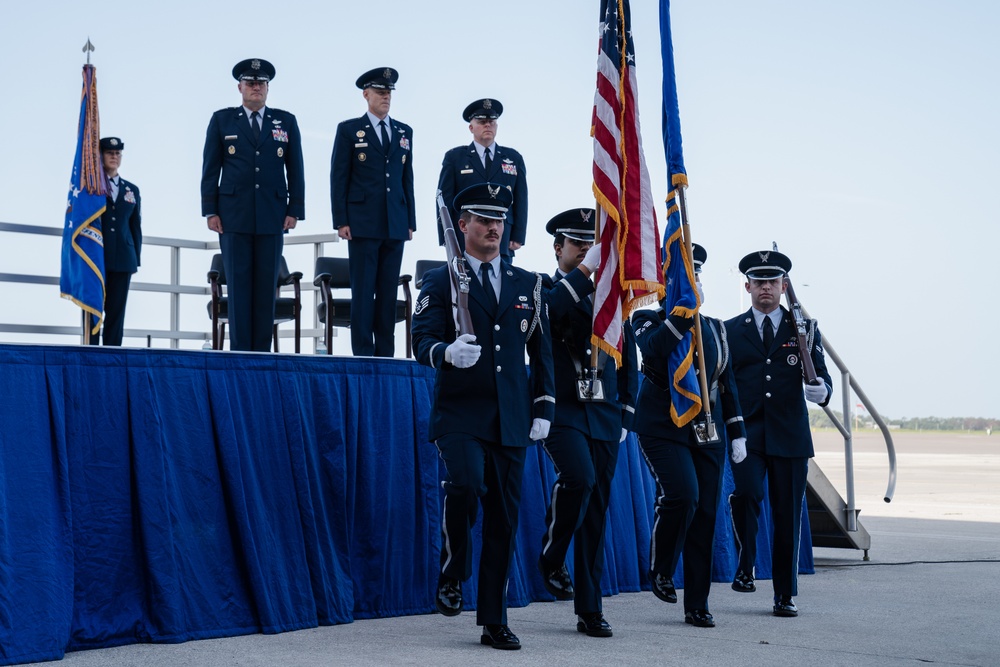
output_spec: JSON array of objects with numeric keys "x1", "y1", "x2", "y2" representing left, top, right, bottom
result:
[{"x1": 542, "y1": 269, "x2": 639, "y2": 614}]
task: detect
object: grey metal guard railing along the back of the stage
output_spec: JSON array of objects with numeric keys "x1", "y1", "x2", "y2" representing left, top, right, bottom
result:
[{"x1": 0, "y1": 222, "x2": 340, "y2": 348}]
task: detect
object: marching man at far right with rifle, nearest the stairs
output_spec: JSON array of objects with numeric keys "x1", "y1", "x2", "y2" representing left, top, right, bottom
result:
[{"x1": 726, "y1": 250, "x2": 833, "y2": 616}]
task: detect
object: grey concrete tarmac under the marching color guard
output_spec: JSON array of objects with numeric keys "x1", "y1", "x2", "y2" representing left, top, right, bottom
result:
[{"x1": 25, "y1": 432, "x2": 1000, "y2": 667}]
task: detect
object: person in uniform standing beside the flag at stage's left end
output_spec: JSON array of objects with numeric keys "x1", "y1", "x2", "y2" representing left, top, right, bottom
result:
[{"x1": 90, "y1": 137, "x2": 142, "y2": 345}]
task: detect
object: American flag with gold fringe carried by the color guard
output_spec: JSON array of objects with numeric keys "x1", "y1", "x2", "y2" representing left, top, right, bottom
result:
[{"x1": 591, "y1": 0, "x2": 663, "y2": 362}]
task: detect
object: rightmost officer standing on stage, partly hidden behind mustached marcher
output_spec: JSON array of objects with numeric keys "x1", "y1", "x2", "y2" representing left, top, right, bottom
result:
[{"x1": 438, "y1": 97, "x2": 528, "y2": 261}]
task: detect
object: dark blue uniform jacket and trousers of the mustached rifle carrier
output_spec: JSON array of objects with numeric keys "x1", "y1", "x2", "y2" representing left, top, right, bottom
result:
[{"x1": 413, "y1": 262, "x2": 555, "y2": 625}]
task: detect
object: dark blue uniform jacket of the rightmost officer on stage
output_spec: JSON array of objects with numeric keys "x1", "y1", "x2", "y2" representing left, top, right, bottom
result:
[{"x1": 434, "y1": 143, "x2": 528, "y2": 260}]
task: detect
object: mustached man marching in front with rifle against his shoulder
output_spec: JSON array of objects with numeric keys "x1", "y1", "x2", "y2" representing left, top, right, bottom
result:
[{"x1": 413, "y1": 183, "x2": 555, "y2": 649}]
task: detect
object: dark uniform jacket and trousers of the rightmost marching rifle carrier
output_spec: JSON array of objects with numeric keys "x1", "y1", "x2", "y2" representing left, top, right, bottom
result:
[{"x1": 726, "y1": 307, "x2": 833, "y2": 596}]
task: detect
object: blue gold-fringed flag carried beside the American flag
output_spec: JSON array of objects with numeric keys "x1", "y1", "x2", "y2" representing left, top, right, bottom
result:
[{"x1": 660, "y1": 0, "x2": 702, "y2": 426}]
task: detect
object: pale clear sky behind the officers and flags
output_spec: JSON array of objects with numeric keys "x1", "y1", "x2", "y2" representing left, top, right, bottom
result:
[{"x1": 0, "y1": 0, "x2": 1000, "y2": 417}]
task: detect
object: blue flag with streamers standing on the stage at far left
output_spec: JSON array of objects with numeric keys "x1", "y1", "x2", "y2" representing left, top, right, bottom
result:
[{"x1": 59, "y1": 64, "x2": 107, "y2": 334}]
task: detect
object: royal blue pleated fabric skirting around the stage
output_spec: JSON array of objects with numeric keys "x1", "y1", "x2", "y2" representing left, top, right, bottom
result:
[{"x1": 0, "y1": 345, "x2": 813, "y2": 664}]
